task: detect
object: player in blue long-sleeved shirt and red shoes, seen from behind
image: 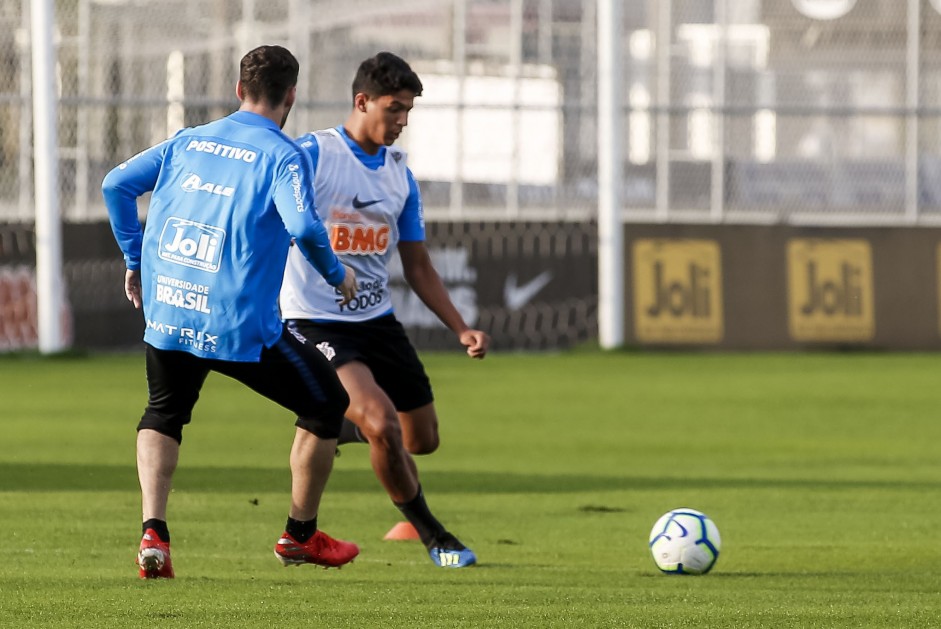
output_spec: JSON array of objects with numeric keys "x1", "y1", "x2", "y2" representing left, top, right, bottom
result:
[{"x1": 102, "y1": 46, "x2": 359, "y2": 578}]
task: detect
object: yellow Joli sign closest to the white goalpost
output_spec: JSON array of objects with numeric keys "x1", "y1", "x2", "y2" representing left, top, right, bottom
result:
[{"x1": 633, "y1": 239, "x2": 724, "y2": 343}]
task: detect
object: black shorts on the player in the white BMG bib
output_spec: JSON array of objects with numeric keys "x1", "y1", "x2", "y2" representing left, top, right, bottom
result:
[{"x1": 287, "y1": 314, "x2": 435, "y2": 413}]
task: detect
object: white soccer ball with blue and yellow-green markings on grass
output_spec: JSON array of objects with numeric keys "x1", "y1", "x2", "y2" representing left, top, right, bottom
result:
[{"x1": 650, "y1": 509, "x2": 722, "y2": 574}]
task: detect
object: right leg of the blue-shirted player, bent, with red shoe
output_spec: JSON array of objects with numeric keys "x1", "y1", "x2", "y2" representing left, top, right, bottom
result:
[{"x1": 214, "y1": 331, "x2": 359, "y2": 567}]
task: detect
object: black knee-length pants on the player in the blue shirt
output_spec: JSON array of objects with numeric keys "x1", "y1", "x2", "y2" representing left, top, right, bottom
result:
[{"x1": 137, "y1": 327, "x2": 350, "y2": 442}]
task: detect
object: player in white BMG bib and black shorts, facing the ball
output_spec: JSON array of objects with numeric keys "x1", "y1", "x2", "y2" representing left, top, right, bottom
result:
[{"x1": 280, "y1": 52, "x2": 490, "y2": 568}]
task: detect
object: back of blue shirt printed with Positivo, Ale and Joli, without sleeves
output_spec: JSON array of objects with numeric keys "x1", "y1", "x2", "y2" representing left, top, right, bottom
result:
[{"x1": 141, "y1": 112, "x2": 305, "y2": 360}]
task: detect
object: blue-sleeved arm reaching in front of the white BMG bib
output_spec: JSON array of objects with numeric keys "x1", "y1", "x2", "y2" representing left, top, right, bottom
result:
[{"x1": 274, "y1": 152, "x2": 356, "y2": 303}]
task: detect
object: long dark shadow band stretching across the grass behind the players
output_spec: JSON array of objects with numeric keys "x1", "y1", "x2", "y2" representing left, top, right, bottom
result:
[{"x1": 0, "y1": 462, "x2": 941, "y2": 494}]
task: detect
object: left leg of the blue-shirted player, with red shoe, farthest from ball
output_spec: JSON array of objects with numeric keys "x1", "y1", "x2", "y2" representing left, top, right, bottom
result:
[{"x1": 137, "y1": 345, "x2": 209, "y2": 579}]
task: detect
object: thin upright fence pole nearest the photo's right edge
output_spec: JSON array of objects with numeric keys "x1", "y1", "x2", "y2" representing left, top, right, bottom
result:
[{"x1": 905, "y1": 0, "x2": 921, "y2": 223}]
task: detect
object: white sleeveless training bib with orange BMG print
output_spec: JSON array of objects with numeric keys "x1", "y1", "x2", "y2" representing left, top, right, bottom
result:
[{"x1": 281, "y1": 129, "x2": 409, "y2": 321}]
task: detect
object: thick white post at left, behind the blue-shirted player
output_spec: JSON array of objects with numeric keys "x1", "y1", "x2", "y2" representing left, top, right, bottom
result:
[{"x1": 31, "y1": 0, "x2": 65, "y2": 354}]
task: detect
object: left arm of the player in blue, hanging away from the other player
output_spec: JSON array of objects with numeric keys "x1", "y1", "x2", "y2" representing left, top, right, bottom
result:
[{"x1": 101, "y1": 142, "x2": 167, "y2": 308}]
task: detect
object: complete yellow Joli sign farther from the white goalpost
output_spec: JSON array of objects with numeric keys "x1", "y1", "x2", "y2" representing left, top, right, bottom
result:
[{"x1": 787, "y1": 238, "x2": 875, "y2": 341}]
